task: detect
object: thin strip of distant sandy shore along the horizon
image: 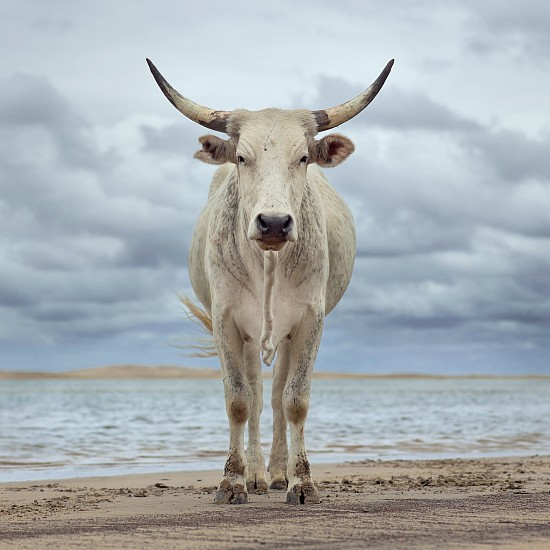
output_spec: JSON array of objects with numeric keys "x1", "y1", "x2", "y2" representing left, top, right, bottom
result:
[{"x1": 0, "y1": 365, "x2": 550, "y2": 380}]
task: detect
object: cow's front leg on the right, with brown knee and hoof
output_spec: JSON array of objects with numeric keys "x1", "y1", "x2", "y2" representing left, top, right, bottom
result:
[{"x1": 283, "y1": 311, "x2": 323, "y2": 504}]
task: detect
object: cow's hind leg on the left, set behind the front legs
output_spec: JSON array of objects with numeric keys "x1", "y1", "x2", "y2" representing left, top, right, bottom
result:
[{"x1": 244, "y1": 342, "x2": 267, "y2": 495}]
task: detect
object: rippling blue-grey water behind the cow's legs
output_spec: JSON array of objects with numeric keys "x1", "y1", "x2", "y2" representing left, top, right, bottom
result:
[{"x1": 0, "y1": 379, "x2": 550, "y2": 482}]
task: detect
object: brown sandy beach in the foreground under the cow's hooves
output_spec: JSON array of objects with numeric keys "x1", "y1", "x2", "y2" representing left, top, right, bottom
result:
[{"x1": 0, "y1": 456, "x2": 550, "y2": 550}]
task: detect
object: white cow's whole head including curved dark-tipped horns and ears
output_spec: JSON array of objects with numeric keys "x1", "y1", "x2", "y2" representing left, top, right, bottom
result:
[{"x1": 147, "y1": 60, "x2": 393, "y2": 250}]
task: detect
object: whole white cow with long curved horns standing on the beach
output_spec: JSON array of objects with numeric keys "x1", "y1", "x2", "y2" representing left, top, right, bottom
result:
[{"x1": 147, "y1": 59, "x2": 393, "y2": 504}]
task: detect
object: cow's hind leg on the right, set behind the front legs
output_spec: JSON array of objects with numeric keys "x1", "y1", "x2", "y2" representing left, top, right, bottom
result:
[{"x1": 268, "y1": 341, "x2": 290, "y2": 490}]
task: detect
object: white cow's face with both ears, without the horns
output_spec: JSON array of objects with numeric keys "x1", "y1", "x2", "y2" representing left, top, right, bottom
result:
[{"x1": 195, "y1": 109, "x2": 354, "y2": 251}]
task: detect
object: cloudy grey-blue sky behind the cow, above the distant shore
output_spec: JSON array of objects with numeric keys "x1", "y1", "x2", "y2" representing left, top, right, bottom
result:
[{"x1": 0, "y1": 0, "x2": 550, "y2": 374}]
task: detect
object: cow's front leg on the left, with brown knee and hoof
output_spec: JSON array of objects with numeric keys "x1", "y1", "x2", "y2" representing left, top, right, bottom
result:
[{"x1": 213, "y1": 317, "x2": 252, "y2": 504}]
